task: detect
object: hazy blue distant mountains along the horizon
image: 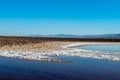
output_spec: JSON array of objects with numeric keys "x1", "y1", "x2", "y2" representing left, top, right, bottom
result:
[{"x1": 29, "y1": 33, "x2": 120, "y2": 38}]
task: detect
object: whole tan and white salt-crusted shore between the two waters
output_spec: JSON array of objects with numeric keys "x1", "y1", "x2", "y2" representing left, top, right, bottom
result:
[{"x1": 0, "y1": 42, "x2": 120, "y2": 62}]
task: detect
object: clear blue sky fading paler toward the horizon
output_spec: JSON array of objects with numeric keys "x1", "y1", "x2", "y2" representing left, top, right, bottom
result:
[{"x1": 0, "y1": 0, "x2": 120, "y2": 35}]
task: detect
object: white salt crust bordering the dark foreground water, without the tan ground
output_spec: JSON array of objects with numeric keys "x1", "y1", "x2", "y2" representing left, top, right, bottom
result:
[{"x1": 0, "y1": 43, "x2": 120, "y2": 62}]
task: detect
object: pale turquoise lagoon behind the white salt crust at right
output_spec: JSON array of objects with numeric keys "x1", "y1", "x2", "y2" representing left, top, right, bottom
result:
[{"x1": 77, "y1": 44, "x2": 120, "y2": 52}]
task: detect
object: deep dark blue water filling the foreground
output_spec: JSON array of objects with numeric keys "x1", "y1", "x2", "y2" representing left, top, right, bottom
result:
[{"x1": 0, "y1": 56, "x2": 120, "y2": 80}]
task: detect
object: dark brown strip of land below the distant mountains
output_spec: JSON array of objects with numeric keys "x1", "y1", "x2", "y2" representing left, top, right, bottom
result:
[{"x1": 0, "y1": 36, "x2": 120, "y2": 47}]
